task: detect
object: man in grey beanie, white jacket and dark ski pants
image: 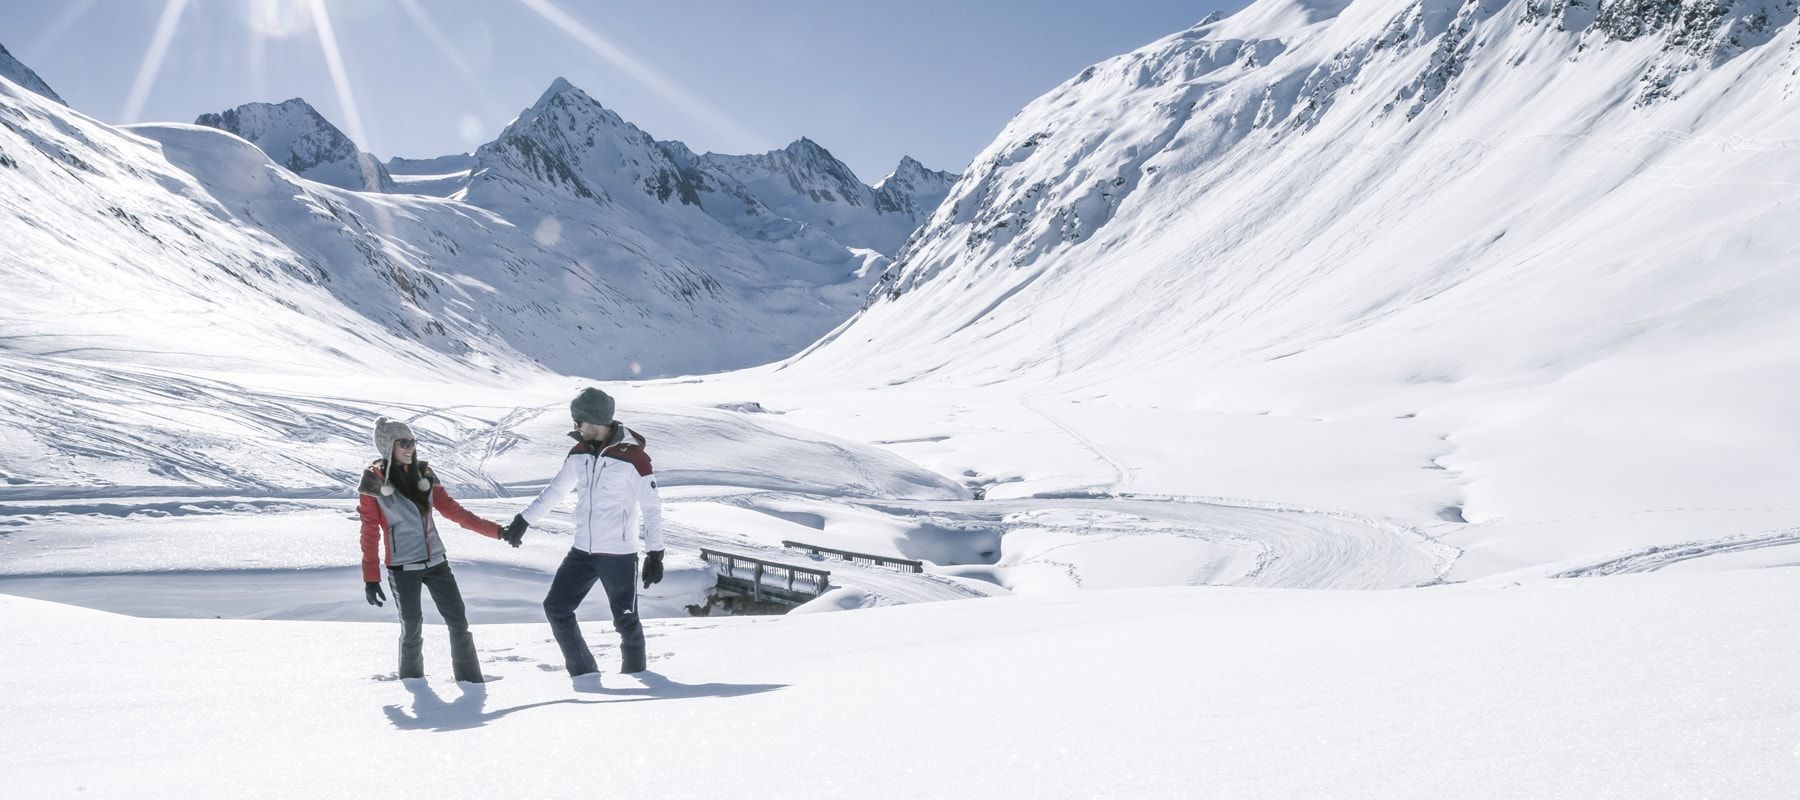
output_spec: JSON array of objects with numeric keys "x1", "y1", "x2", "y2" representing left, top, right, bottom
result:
[{"x1": 500, "y1": 387, "x2": 662, "y2": 677}]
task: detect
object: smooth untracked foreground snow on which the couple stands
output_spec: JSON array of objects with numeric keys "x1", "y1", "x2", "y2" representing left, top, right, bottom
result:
[{"x1": 0, "y1": 569, "x2": 1800, "y2": 800}]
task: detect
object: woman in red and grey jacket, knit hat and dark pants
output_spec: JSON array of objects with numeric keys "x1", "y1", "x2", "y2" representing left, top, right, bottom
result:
[{"x1": 356, "y1": 416, "x2": 517, "y2": 683}]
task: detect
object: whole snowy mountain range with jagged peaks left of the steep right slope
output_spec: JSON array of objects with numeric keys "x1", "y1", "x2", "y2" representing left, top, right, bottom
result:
[{"x1": 0, "y1": 56, "x2": 954, "y2": 377}]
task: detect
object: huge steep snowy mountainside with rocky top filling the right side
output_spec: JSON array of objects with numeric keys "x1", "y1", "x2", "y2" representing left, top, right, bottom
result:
[{"x1": 781, "y1": 0, "x2": 1800, "y2": 575}]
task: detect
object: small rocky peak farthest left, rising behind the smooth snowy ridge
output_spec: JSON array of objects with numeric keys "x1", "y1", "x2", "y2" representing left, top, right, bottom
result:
[{"x1": 194, "y1": 97, "x2": 396, "y2": 191}]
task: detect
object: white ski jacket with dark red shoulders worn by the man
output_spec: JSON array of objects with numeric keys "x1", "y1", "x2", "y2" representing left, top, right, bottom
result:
[{"x1": 520, "y1": 423, "x2": 662, "y2": 555}]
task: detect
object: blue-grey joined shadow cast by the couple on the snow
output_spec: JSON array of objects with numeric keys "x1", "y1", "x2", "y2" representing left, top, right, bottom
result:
[{"x1": 382, "y1": 672, "x2": 787, "y2": 730}]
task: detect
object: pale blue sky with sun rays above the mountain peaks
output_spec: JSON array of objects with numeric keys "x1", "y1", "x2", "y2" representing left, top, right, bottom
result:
[{"x1": 10, "y1": 0, "x2": 1244, "y2": 182}]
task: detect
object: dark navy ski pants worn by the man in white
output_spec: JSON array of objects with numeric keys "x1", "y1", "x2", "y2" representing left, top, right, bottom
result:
[{"x1": 544, "y1": 550, "x2": 644, "y2": 676}]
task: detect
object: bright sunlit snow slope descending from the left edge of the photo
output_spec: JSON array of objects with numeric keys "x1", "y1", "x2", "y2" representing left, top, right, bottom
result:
[{"x1": 0, "y1": 81, "x2": 446, "y2": 374}]
